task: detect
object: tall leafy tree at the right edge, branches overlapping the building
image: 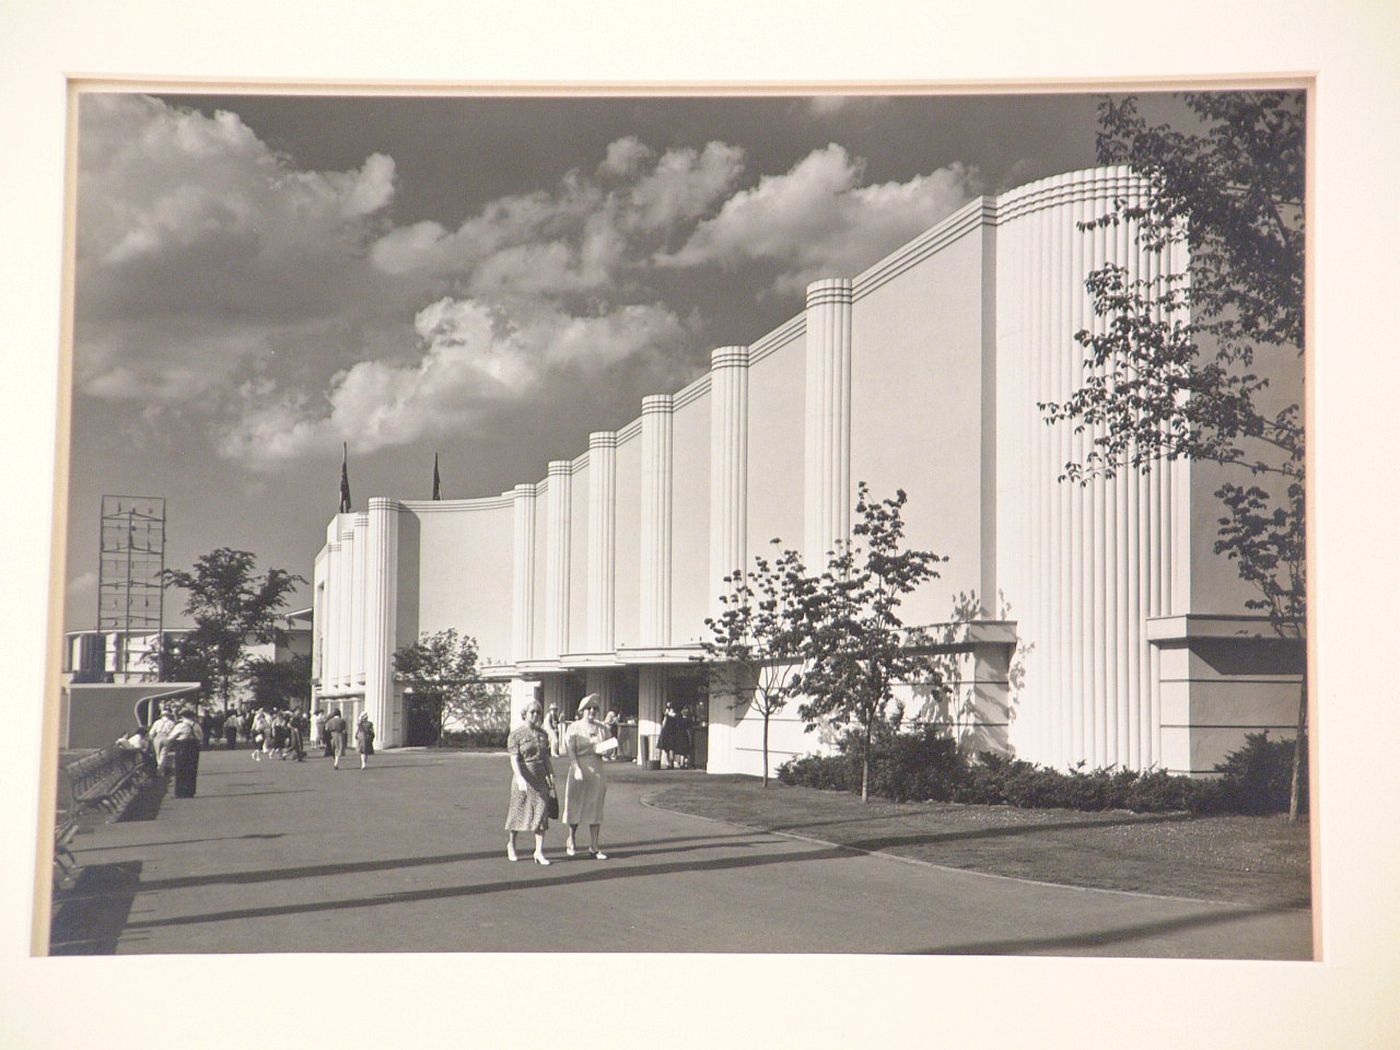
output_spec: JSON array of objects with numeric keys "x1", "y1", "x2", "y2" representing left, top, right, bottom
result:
[{"x1": 1042, "y1": 91, "x2": 1308, "y2": 819}]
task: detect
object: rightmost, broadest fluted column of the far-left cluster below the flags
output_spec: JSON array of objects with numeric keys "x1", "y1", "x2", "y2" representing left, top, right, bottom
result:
[{"x1": 364, "y1": 496, "x2": 405, "y2": 745}]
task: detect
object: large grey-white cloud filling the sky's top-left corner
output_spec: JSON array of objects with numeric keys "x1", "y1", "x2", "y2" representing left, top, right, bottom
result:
[{"x1": 76, "y1": 94, "x2": 396, "y2": 402}]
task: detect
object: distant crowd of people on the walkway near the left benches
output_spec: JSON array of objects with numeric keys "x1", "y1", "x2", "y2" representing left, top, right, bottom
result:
[{"x1": 116, "y1": 701, "x2": 375, "y2": 798}]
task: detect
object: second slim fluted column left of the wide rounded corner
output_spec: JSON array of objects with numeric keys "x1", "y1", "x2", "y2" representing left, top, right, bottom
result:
[{"x1": 710, "y1": 346, "x2": 749, "y2": 616}]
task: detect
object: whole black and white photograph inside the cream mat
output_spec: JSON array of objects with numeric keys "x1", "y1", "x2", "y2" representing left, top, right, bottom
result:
[{"x1": 49, "y1": 88, "x2": 1313, "y2": 959}]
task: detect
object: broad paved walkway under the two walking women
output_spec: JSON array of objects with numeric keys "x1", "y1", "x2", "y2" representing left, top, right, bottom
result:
[{"x1": 46, "y1": 750, "x2": 1310, "y2": 959}]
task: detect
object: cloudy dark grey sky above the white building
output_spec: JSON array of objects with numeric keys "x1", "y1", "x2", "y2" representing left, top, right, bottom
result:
[{"x1": 64, "y1": 92, "x2": 1151, "y2": 630}]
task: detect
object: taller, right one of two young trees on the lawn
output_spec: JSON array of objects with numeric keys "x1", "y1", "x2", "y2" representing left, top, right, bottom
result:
[{"x1": 792, "y1": 482, "x2": 946, "y2": 802}]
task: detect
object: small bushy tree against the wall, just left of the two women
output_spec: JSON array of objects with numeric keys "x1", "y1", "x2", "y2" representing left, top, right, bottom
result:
[{"x1": 393, "y1": 627, "x2": 501, "y2": 743}]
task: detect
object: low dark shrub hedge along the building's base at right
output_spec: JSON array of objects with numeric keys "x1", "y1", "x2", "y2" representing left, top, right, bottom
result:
[{"x1": 778, "y1": 727, "x2": 1308, "y2": 813}]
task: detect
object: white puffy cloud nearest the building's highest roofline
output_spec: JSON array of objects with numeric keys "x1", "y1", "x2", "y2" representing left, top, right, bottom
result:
[{"x1": 657, "y1": 143, "x2": 979, "y2": 291}]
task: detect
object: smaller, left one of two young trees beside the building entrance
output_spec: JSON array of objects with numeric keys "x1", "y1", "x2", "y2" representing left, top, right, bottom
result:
[{"x1": 701, "y1": 539, "x2": 816, "y2": 787}]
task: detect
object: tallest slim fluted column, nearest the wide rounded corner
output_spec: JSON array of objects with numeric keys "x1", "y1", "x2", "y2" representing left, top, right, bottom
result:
[{"x1": 802, "y1": 277, "x2": 851, "y2": 568}]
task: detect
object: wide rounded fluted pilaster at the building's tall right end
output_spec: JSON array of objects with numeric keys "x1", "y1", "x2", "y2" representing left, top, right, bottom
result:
[{"x1": 997, "y1": 168, "x2": 1187, "y2": 769}]
